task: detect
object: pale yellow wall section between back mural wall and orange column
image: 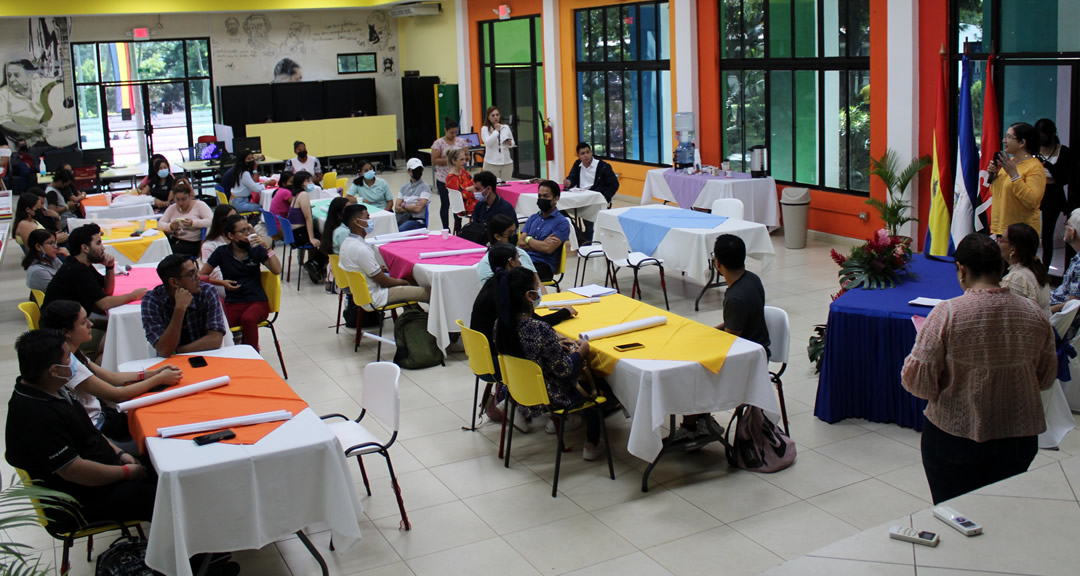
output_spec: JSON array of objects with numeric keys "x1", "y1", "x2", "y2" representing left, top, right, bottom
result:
[{"x1": 397, "y1": 0, "x2": 458, "y2": 84}]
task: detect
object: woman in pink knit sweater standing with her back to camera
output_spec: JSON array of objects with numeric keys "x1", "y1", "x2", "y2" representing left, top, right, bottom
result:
[{"x1": 901, "y1": 232, "x2": 1057, "y2": 504}]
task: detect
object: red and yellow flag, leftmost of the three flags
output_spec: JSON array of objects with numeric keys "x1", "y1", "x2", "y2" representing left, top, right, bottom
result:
[{"x1": 922, "y1": 46, "x2": 954, "y2": 256}]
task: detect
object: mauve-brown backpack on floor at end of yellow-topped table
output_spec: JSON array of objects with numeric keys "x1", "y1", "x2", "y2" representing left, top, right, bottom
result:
[{"x1": 724, "y1": 404, "x2": 795, "y2": 472}]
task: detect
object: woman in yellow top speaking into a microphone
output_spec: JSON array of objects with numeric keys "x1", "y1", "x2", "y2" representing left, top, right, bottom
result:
[{"x1": 986, "y1": 122, "x2": 1047, "y2": 235}]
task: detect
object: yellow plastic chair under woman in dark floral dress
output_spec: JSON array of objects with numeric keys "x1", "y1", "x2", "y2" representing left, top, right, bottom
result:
[{"x1": 499, "y1": 354, "x2": 615, "y2": 498}]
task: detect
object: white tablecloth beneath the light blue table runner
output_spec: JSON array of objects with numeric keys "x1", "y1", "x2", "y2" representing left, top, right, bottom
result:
[{"x1": 596, "y1": 204, "x2": 775, "y2": 284}]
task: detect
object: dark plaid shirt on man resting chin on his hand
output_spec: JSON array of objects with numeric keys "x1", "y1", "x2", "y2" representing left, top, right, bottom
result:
[{"x1": 143, "y1": 282, "x2": 229, "y2": 346}]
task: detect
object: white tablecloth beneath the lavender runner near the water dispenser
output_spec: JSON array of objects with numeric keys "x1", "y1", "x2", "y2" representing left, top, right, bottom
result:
[{"x1": 639, "y1": 169, "x2": 780, "y2": 227}]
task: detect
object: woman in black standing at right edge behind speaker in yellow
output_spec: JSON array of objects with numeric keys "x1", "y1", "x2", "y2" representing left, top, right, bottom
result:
[{"x1": 1032, "y1": 118, "x2": 1080, "y2": 266}]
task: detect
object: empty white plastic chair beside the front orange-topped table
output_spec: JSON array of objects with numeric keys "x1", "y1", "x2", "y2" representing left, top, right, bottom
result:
[{"x1": 322, "y1": 362, "x2": 413, "y2": 529}]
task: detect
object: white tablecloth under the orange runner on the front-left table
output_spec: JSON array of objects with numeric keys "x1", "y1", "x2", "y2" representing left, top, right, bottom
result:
[{"x1": 118, "y1": 346, "x2": 363, "y2": 576}]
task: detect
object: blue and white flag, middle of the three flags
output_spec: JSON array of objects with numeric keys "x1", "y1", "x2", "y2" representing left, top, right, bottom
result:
[{"x1": 953, "y1": 54, "x2": 978, "y2": 240}]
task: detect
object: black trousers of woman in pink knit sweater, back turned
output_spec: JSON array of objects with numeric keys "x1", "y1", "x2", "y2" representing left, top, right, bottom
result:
[{"x1": 922, "y1": 420, "x2": 1039, "y2": 505}]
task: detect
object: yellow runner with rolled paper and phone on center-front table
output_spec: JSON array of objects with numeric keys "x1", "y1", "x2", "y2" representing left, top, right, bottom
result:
[{"x1": 540, "y1": 292, "x2": 735, "y2": 375}]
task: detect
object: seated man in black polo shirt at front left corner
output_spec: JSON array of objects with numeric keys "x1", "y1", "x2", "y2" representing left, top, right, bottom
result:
[{"x1": 5, "y1": 330, "x2": 157, "y2": 532}]
